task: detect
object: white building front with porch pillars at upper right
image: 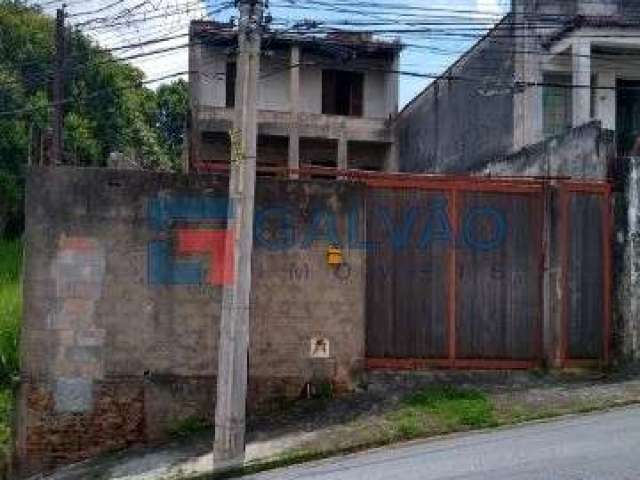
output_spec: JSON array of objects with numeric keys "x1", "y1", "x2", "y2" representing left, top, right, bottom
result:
[{"x1": 513, "y1": 0, "x2": 640, "y2": 154}]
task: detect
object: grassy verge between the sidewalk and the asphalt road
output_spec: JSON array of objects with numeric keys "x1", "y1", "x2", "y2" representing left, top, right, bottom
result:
[{"x1": 179, "y1": 386, "x2": 640, "y2": 480}]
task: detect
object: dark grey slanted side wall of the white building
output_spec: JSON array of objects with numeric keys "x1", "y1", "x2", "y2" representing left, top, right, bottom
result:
[{"x1": 396, "y1": 20, "x2": 514, "y2": 173}]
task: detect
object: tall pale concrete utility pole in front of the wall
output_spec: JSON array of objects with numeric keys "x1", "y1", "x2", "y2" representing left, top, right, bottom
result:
[{"x1": 213, "y1": 0, "x2": 264, "y2": 470}]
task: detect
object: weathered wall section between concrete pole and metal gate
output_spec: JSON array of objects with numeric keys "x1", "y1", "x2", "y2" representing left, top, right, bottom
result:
[{"x1": 249, "y1": 182, "x2": 365, "y2": 403}]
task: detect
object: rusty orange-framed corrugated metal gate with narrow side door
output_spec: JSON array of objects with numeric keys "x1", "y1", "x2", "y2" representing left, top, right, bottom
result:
[{"x1": 366, "y1": 177, "x2": 610, "y2": 368}]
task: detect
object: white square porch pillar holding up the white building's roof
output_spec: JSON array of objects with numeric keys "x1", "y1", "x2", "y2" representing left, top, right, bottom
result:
[{"x1": 571, "y1": 38, "x2": 591, "y2": 128}]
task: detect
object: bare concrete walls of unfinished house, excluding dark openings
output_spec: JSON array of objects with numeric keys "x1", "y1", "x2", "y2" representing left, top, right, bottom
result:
[{"x1": 189, "y1": 21, "x2": 401, "y2": 170}]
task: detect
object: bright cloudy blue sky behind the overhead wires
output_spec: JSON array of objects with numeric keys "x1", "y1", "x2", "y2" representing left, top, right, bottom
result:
[{"x1": 51, "y1": 0, "x2": 509, "y2": 105}]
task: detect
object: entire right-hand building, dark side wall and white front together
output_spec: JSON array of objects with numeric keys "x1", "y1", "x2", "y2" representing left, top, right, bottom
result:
[{"x1": 397, "y1": 0, "x2": 640, "y2": 173}]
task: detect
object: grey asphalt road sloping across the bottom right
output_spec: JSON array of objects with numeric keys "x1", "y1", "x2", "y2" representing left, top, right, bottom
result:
[{"x1": 248, "y1": 408, "x2": 640, "y2": 480}]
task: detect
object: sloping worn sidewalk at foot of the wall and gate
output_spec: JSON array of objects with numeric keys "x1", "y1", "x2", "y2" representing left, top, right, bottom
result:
[{"x1": 27, "y1": 378, "x2": 640, "y2": 480}]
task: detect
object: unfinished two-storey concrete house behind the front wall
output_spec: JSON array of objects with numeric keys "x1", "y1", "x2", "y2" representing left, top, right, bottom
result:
[{"x1": 189, "y1": 21, "x2": 401, "y2": 171}]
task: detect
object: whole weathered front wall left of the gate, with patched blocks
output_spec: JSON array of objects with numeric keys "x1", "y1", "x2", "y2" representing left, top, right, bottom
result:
[{"x1": 15, "y1": 168, "x2": 364, "y2": 473}]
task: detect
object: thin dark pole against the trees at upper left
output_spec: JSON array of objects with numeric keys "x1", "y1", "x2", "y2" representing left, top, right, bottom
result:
[{"x1": 50, "y1": 4, "x2": 65, "y2": 165}]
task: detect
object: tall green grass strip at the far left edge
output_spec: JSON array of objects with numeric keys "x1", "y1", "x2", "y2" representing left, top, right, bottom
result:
[{"x1": 0, "y1": 239, "x2": 22, "y2": 458}]
